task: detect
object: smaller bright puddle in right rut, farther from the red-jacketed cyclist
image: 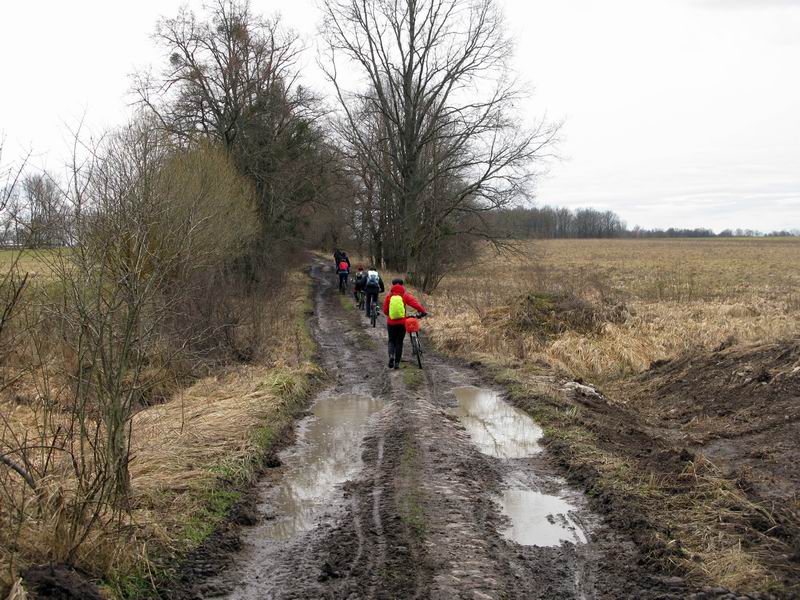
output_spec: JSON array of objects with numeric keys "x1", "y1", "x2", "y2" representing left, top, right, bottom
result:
[{"x1": 498, "y1": 489, "x2": 587, "y2": 546}]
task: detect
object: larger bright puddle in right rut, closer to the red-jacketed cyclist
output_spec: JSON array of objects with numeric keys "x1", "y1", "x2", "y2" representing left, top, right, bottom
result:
[{"x1": 448, "y1": 386, "x2": 542, "y2": 458}]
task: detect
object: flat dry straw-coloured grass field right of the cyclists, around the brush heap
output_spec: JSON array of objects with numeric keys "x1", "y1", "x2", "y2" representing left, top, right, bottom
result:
[{"x1": 427, "y1": 239, "x2": 800, "y2": 381}]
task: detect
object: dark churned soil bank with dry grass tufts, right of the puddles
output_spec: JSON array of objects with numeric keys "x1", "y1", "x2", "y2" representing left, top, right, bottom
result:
[{"x1": 534, "y1": 340, "x2": 800, "y2": 598}]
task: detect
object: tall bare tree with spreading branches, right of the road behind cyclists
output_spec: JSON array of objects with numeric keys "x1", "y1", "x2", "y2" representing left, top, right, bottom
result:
[{"x1": 323, "y1": 0, "x2": 558, "y2": 289}]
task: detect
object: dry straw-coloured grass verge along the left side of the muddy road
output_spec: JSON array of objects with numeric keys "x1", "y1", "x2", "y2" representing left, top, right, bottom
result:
[{"x1": 0, "y1": 272, "x2": 318, "y2": 597}]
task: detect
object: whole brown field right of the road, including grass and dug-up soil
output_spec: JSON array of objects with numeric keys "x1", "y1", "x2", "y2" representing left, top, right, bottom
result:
[{"x1": 425, "y1": 239, "x2": 800, "y2": 597}]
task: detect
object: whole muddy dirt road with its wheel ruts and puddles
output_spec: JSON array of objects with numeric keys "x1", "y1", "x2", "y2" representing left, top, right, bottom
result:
[{"x1": 182, "y1": 265, "x2": 705, "y2": 599}]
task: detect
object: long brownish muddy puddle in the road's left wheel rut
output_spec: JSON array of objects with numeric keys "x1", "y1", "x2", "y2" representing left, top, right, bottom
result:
[{"x1": 257, "y1": 395, "x2": 383, "y2": 540}]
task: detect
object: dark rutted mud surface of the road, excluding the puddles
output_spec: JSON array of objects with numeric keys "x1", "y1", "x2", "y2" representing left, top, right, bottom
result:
[{"x1": 180, "y1": 264, "x2": 685, "y2": 600}]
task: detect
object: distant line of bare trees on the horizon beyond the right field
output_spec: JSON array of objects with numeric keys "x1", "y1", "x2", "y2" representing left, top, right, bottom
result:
[{"x1": 487, "y1": 206, "x2": 800, "y2": 239}]
